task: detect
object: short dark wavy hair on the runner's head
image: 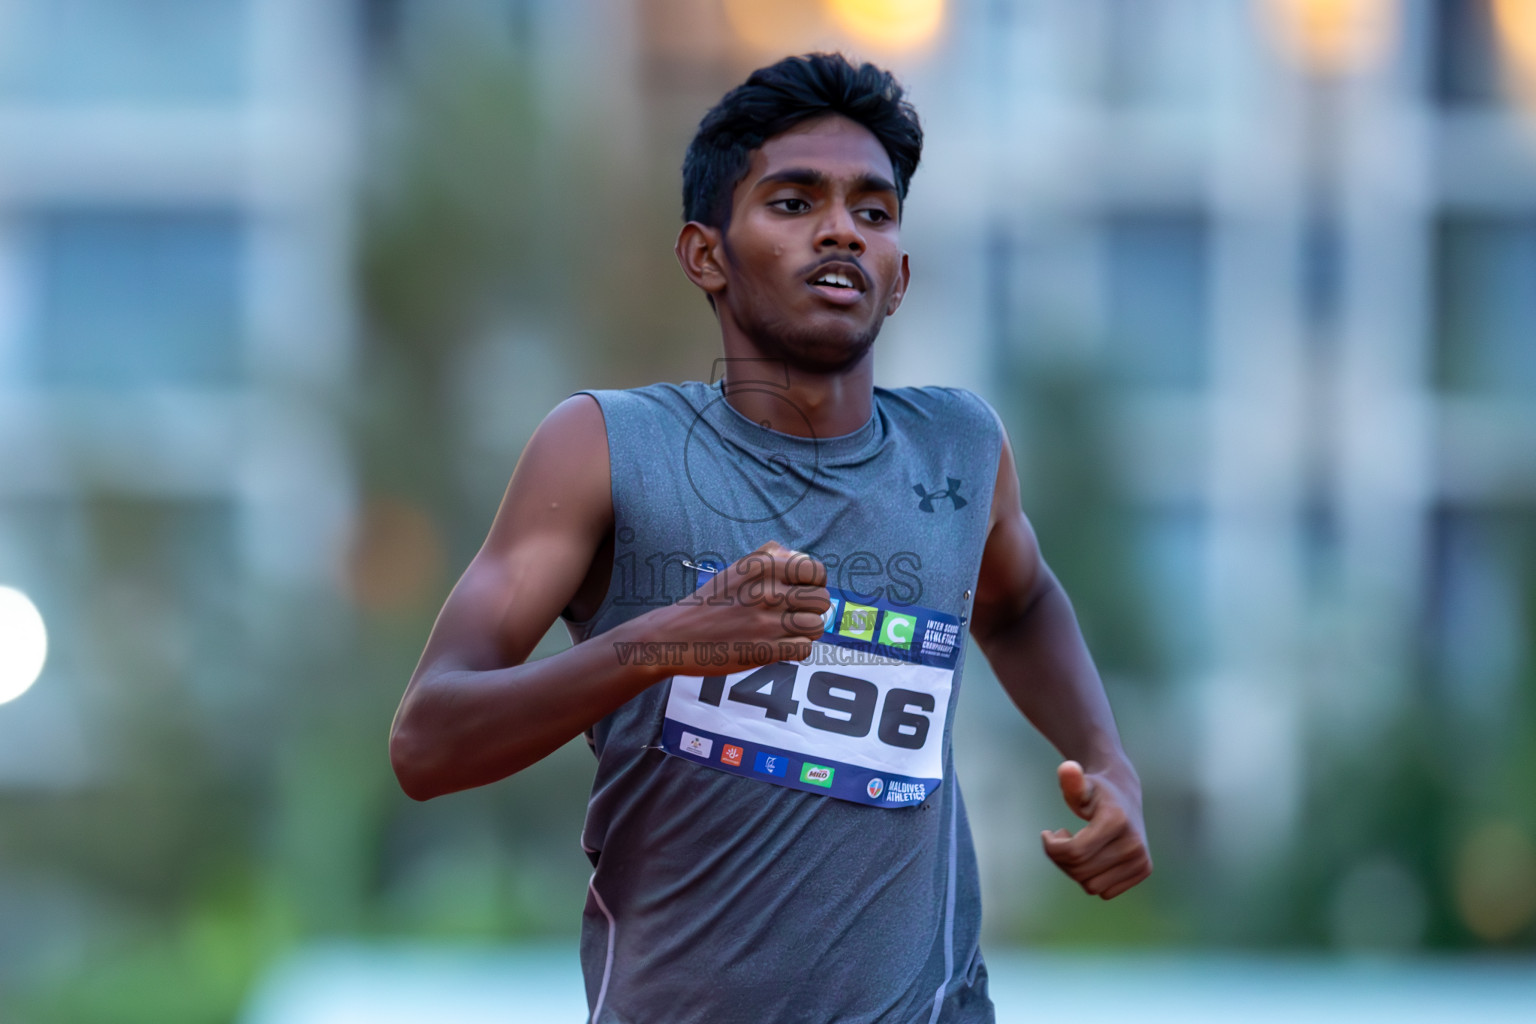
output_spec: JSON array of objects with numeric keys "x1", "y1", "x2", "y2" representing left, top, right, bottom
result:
[{"x1": 682, "y1": 54, "x2": 923, "y2": 227}]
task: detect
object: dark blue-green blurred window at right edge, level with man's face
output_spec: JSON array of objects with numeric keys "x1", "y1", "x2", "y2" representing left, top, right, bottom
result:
[{"x1": 1435, "y1": 216, "x2": 1536, "y2": 398}]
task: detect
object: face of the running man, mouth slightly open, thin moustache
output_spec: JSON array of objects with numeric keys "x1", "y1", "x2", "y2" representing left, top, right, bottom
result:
[{"x1": 714, "y1": 115, "x2": 908, "y2": 373}]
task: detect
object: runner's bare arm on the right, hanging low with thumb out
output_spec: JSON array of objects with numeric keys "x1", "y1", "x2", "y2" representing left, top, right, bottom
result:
[{"x1": 971, "y1": 423, "x2": 1152, "y2": 900}]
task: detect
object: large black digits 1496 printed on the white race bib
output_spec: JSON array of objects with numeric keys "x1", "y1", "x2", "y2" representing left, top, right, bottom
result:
[{"x1": 699, "y1": 662, "x2": 934, "y2": 751}]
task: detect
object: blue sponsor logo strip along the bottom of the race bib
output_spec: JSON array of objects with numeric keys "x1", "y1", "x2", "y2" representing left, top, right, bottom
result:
[{"x1": 662, "y1": 720, "x2": 940, "y2": 808}]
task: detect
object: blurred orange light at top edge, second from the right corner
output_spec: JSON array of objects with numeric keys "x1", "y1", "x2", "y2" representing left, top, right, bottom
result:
[{"x1": 1264, "y1": 0, "x2": 1398, "y2": 75}]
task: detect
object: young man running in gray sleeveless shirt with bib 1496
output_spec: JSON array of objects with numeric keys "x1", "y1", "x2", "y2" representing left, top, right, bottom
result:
[{"x1": 390, "y1": 55, "x2": 1150, "y2": 1024}]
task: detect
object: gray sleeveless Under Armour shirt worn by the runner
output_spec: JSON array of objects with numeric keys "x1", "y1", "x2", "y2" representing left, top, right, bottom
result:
[{"x1": 570, "y1": 382, "x2": 1001, "y2": 1024}]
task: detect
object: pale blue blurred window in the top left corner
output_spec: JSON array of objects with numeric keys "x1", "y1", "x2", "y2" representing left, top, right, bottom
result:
[{"x1": 0, "y1": 0, "x2": 250, "y2": 103}]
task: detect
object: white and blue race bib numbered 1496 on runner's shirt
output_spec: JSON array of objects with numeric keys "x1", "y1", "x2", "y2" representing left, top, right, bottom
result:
[{"x1": 662, "y1": 588, "x2": 962, "y2": 808}]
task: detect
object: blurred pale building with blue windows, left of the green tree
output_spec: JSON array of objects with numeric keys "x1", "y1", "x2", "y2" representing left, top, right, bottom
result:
[{"x1": 0, "y1": 0, "x2": 356, "y2": 788}]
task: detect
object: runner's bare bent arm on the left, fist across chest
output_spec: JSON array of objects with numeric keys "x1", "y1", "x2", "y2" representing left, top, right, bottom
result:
[{"x1": 390, "y1": 395, "x2": 828, "y2": 800}]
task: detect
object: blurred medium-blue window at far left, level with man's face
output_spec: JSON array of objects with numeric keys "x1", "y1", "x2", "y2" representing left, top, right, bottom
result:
[{"x1": 25, "y1": 210, "x2": 244, "y2": 385}]
